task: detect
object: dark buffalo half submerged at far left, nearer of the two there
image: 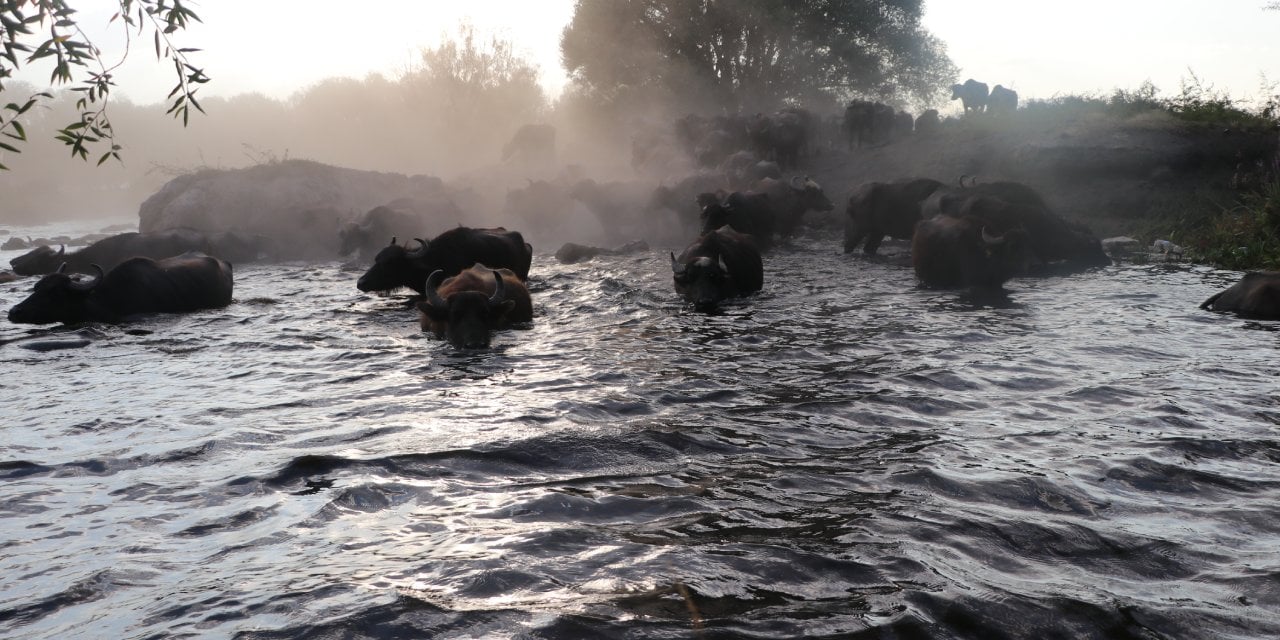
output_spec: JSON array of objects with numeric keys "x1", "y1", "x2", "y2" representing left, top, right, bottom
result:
[{"x1": 9, "y1": 252, "x2": 232, "y2": 324}]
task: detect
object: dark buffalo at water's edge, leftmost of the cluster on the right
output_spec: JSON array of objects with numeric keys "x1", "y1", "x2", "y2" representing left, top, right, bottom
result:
[{"x1": 845, "y1": 178, "x2": 942, "y2": 256}]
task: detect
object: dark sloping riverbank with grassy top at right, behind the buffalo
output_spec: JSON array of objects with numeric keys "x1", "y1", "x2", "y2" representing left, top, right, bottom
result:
[{"x1": 808, "y1": 104, "x2": 1280, "y2": 269}]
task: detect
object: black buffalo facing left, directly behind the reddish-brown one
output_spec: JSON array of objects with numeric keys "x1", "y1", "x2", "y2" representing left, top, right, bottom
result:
[{"x1": 356, "y1": 227, "x2": 534, "y2": 294}]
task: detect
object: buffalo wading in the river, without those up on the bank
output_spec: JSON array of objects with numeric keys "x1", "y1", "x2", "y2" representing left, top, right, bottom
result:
[{"x1": 9, "y1": 167, "x2": 1280, "y2": 348}]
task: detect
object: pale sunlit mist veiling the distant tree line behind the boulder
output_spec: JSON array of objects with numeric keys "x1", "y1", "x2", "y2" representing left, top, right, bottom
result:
[{"x1": 0, "y1": 38, "x2": 721, "y2": 252}]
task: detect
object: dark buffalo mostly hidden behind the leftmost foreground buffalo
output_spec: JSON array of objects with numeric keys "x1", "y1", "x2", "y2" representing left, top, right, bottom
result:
[{"x1": 9, "y1": 229, "x2": 218, "y2": 275}]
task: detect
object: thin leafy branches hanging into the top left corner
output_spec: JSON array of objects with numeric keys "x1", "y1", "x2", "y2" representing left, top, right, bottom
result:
[{"x1": 0, "y1": 0, "x2": 209, "y2": 170}]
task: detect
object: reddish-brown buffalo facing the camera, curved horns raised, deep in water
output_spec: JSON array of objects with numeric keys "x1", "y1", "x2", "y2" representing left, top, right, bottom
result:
[{"x1": 417, "y1": 264, "x2": 534, "y2": 348}]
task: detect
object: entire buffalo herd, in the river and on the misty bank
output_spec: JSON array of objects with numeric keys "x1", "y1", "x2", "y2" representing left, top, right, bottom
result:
[{"x1": 9, "y1": 92, "x2": 1280, "y2": 348}]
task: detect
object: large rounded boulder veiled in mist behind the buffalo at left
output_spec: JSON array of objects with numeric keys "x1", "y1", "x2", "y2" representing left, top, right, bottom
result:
[{"x1": 138, "y1": 160, "x2": 476, "y2": 260}]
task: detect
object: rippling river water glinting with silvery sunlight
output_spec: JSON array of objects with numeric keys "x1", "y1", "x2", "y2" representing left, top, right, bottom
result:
[{"x1": 0, "y1": 220, "x2": 1280, "y2": 639}]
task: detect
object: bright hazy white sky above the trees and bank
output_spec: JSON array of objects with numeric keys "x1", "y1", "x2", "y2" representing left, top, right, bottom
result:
[{"x1": 12, "y1": 0, "x2": 1280, "y2": 108}]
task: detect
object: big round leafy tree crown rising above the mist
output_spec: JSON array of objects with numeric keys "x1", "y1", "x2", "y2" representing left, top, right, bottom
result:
[{"x1": 561, "y1": 0, "x2": 956, "y2": 110}]
